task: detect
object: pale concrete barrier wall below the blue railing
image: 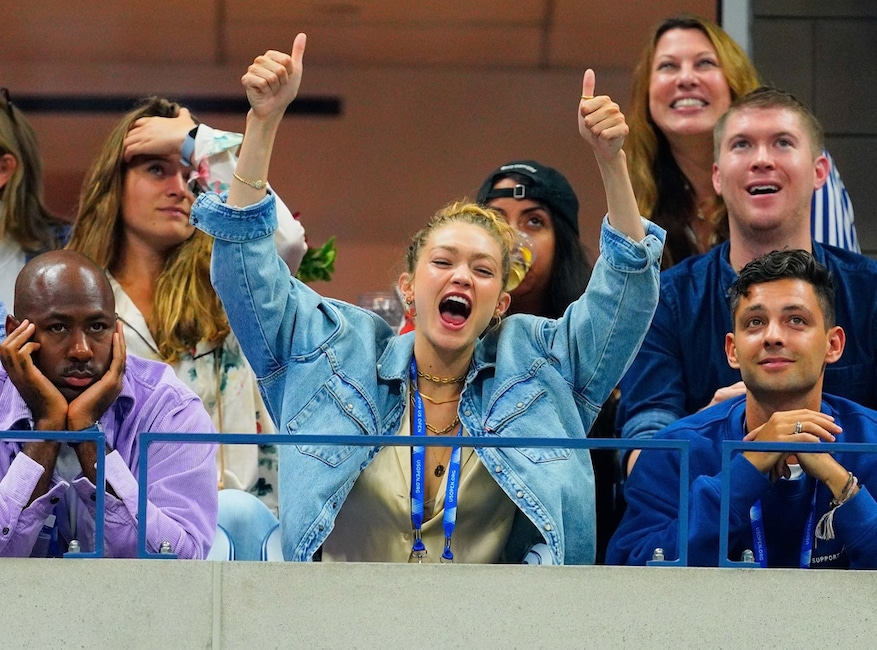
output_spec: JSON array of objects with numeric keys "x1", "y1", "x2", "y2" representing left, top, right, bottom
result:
[{"x1": 0, "y1": 560, "x2": 877, "y2": 650}]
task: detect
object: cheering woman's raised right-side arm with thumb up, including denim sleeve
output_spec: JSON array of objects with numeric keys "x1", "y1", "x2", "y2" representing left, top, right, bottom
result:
[{"x1": 550, "y1": 69, "x2": 665, "y2": 420}]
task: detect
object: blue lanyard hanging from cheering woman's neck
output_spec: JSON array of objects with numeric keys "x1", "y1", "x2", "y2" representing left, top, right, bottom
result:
[{"x1": 409, "y1": 357, "x2": 463, "y2": 562}]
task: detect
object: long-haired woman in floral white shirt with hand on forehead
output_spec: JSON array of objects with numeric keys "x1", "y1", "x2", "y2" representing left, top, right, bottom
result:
[{"x1": 68, "y1": 97, "x2": 306, "y2": 560}]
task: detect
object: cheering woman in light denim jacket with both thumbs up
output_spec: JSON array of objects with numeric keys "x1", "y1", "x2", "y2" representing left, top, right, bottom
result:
[{"x1": 192, "y1": 34, "x2": 663, "y2": 563}]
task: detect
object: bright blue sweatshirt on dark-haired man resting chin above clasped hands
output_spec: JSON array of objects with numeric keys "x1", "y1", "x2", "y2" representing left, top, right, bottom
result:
[{"x1": 606, "y1": 395, "x2": 877, "y2": 569}]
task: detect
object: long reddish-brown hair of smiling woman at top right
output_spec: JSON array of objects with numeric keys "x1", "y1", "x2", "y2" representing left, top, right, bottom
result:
[{"x1": 625, "y1": 14, "x2": 760, "y2": 265}]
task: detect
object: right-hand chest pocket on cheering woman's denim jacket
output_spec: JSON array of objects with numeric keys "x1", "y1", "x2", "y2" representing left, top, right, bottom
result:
[{"x1": 484, "y1": 380, "x2": 571, "y2": 463}]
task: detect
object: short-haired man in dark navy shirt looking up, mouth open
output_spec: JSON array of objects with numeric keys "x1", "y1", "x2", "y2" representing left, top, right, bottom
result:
[{"x1": 617, "y1": 88, "x2": 877, "y2": 465}]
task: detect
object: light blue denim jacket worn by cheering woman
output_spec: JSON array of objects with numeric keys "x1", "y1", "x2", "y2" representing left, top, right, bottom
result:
[{"x1": 192, "y1": 194, "x2": 664, "y2": 564}]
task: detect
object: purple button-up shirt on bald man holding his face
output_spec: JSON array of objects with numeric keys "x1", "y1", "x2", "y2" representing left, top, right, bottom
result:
[{"x1": 0, "y1": 354, "x2": 217, "y2": 558}]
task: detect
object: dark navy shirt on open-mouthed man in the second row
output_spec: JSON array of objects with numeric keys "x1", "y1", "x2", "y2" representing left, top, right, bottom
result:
[{"x1": 617, "y1": 242, "x2": 877, "y2": 438}]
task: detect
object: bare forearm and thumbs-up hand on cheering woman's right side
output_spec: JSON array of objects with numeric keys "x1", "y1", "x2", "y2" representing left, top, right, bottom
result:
[{"x1": 579, "y1": 68, "x2": 646, "y2": 241}]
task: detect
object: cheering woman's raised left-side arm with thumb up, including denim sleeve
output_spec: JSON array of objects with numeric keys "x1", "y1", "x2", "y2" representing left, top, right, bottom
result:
[{"x1": 192, "y1": 34, "x2": 328, "y2": 394}]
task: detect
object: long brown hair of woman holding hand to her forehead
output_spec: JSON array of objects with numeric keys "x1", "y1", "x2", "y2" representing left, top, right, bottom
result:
[{"x1": 67, "y1": 97, "x2": 230, "y2": 363}]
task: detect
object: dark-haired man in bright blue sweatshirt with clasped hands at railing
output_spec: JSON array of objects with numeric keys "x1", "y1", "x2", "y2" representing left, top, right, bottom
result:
[{"x1": 607, "y1": 250, "x2": 877, "y2": 569}]
